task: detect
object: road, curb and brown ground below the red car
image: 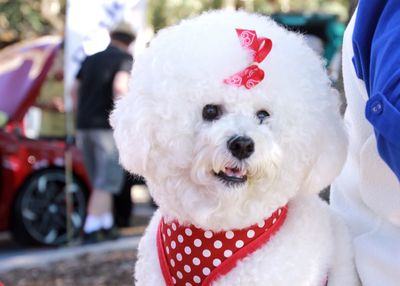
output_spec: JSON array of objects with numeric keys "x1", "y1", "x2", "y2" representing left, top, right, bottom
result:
[{"x1": 0, "y1": 201, "x2": 154, "y2": 286}]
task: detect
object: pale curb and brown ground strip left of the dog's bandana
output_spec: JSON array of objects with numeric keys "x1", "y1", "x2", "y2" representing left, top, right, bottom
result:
[{"x1": 0, "y1": 240, "x2": 139, "y2": 286}]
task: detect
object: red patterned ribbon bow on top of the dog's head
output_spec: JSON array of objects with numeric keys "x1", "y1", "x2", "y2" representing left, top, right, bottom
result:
[{"x1": 224, "y1": 29, "x2": 272, "y2": 89}]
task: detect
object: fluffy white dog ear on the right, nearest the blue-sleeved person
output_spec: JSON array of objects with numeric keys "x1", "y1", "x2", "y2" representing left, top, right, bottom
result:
[{"x1": 301, "y1": 109, "x2": 347, "y2": 193}]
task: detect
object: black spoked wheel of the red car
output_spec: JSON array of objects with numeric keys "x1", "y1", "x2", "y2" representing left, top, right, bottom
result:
[{"x1": 12, "y1": 169, "x2": 88, "y2": 246}]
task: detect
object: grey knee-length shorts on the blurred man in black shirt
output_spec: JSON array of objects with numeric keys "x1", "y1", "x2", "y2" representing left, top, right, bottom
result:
[{"x1": 76, "y1": 129, "x2": 124, "y2": 194}]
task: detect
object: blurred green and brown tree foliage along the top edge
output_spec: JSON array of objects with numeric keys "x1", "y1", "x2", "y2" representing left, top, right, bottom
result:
[{"x1": 0, "y1": 0, "x2": 348, "y2": 48}]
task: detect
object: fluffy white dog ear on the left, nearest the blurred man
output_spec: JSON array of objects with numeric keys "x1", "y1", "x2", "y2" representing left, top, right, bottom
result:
[{"x1": 110, "y1": 95, "x2": 154, "y2": 176}]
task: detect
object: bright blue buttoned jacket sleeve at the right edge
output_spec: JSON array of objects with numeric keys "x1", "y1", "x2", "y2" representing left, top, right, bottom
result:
[{"x1": 353, "y1": 0, "x2": 400, "y2": 180}]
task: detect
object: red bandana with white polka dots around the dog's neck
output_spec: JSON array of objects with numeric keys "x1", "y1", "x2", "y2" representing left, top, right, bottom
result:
[{"x1": 157, "y1": 206, "x2": 287, "y2": 286}]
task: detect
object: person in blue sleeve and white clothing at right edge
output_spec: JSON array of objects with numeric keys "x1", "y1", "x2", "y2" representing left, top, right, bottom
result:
[{"x1": 331, "y1": 0, "x2": 400, "y2": 286}]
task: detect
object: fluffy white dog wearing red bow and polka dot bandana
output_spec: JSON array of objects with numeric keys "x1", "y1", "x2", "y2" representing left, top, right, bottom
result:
[{"x1": 111, "y1": 11, "x2": 357, "y2": 286}]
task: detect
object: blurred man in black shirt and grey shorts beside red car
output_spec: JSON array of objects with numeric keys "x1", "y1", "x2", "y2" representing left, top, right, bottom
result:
[{"x1": 72, "y1": 23, "x2": 135, "y2": 243}]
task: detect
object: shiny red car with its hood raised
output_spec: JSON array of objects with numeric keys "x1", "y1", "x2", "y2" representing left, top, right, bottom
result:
[{"x1": 0, "y1": 37, "x2": 90, "y2": 245}]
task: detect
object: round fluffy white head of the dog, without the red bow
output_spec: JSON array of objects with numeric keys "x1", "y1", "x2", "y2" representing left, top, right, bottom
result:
[{"x1": 111, "y1": 11, "x2": 346, "y2": 230}]
